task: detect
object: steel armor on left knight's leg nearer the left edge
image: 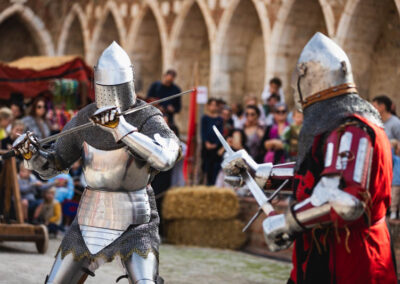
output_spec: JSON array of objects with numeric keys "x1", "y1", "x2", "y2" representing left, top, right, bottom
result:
[{"x1": 45, "y1": 252, "x2": 94, "y2": 284}]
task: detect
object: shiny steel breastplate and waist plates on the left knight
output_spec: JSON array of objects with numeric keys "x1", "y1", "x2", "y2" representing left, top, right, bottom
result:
[{"x1": 77, "y1": 142, "x2": 151, "y2": 254}]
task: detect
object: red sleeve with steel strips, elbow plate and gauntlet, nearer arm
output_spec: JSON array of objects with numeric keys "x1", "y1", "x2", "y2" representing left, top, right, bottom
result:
[{"x1": 263, "y1": 125, "x2": 373, "y2": 251}]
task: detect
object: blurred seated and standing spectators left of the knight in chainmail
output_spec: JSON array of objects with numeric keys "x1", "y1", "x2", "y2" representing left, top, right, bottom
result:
[{"x1": 0, "y1": 93, "x2": 85, "y2": 236}]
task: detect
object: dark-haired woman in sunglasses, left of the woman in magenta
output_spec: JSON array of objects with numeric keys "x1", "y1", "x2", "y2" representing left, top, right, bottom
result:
[{"x1": 243, "y1": 105, "x2": 264, "y2": 160}]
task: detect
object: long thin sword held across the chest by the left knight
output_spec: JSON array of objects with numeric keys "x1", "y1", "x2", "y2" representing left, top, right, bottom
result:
[{"x1": 1, "y1": 89, "x2": 194, "y2": 159}]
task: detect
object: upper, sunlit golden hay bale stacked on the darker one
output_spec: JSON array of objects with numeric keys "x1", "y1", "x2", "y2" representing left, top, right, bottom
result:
[{"x1": 162, "y1": 186, "x2": 239, "y2": 220}]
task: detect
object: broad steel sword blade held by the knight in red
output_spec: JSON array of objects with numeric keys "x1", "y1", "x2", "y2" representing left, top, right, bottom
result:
[{"x1": 213, "y1": 125, "x2": 274, "y2": 216}]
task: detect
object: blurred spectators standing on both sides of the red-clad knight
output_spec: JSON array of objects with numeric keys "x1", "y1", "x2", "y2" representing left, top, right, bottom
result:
[{"x1": 201, "y1": 78, "x2": 400, "y2": 222}]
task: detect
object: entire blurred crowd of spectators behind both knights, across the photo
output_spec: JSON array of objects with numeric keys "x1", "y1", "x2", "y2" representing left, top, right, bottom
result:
[{"x1": 0, "y1": 70, "x2": 400, "y2": 235}]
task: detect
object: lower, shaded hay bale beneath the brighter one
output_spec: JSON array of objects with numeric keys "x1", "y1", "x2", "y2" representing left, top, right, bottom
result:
[{"x1": 166, "y1": 220, "x2": 246, "y2": 249}]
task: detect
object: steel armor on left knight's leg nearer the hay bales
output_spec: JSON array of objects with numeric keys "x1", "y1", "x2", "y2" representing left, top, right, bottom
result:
[{"x1": 123, "y1": 252, "x2": 158, "y2": 284}]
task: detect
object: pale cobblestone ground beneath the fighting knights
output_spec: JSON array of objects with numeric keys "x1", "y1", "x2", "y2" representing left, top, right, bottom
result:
[{"x1": 0, "y1": 240, "x2": 291, "y2": 284}]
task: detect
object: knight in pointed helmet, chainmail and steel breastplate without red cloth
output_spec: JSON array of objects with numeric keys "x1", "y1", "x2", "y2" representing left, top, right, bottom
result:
[{"x1": 14, "y1": 42, "x2": 180, "y2": 284}]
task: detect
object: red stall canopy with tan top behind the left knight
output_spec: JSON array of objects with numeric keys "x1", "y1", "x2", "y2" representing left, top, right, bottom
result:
[{"x1": 0, "y1": 56, "x2": 93, "y2": 99}]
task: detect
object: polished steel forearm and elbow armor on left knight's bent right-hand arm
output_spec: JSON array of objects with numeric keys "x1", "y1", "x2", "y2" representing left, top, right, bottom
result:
[{"x1": 114, "y1": 115, "x2": 180, "y2": 171}]
